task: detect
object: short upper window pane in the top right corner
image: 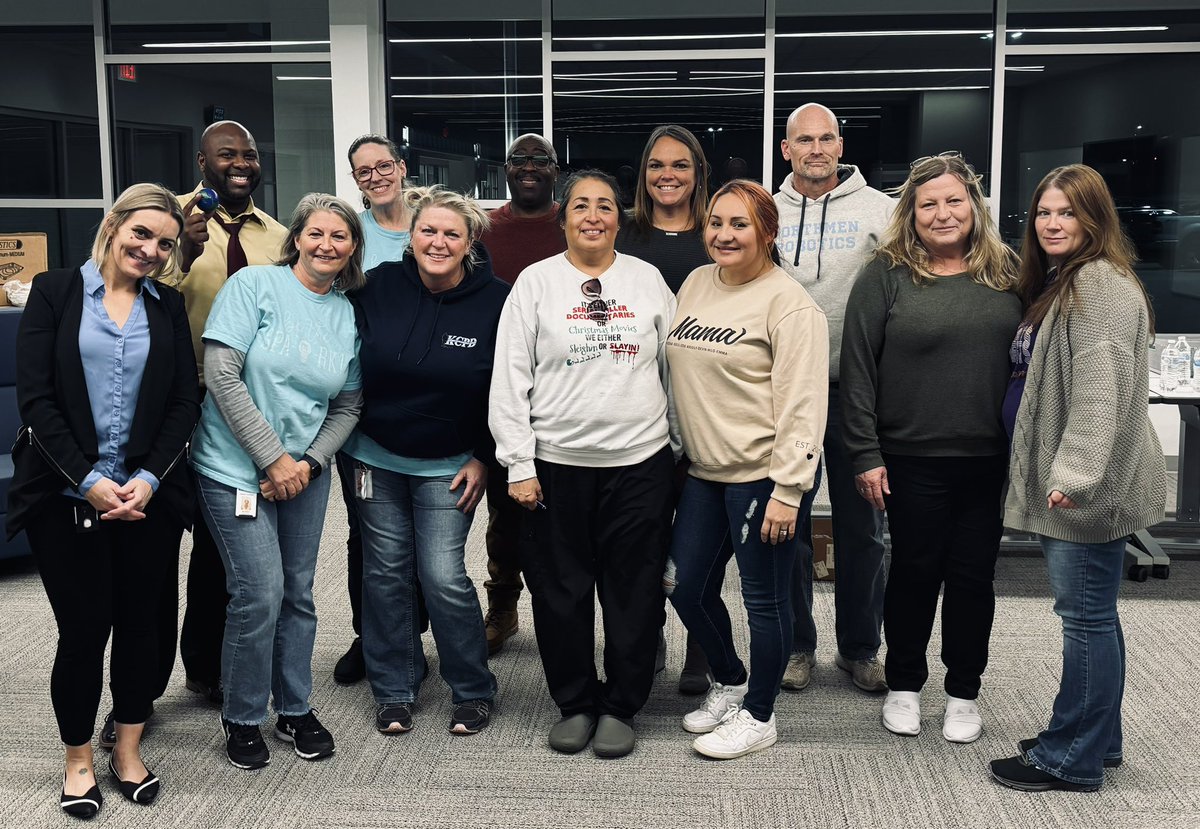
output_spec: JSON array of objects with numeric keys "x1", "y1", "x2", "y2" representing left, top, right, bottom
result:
[{"x1": 1008, "y1": 0, "x2": 1200, "y2": 46}]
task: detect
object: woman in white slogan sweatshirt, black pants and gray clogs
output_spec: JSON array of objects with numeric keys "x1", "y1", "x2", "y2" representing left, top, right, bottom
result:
[{"x1": 488, "y1": 170, "x2": 674, "y2": 757}]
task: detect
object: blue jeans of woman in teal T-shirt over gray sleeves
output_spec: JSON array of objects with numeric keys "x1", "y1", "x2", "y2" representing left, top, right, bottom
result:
[{"x1": 196, "y1": 475, "x2": 330, "y2": 726}]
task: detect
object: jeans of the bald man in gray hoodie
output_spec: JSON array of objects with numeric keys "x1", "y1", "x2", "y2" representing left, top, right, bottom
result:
[{"x1": 792, "y1": 386, "x2": 887, "y2": 660}]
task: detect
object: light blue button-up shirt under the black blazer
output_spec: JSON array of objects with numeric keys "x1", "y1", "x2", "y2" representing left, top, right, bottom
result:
[{"x1": 68, "y1": 259, "x2": 158, "y2": 495}]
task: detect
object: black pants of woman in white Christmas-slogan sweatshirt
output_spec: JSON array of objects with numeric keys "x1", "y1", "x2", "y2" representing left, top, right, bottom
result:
[{"x1": 522, "y1": 447, "x2": 674, "y2": 717}]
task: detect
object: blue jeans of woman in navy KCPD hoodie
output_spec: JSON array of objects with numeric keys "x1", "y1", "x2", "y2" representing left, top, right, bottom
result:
[{"x1": 355, "y1": 462, "x2": 496, "y2": 705}]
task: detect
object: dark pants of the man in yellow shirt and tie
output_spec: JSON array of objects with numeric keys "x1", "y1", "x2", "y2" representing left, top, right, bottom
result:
[{"x1": 176, "y1": 491, "x2": 229, "y2": 687}]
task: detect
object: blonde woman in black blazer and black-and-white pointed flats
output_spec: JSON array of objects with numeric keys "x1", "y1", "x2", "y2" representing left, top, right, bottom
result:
[{"x1": 7, "y1": 185, "x2": 199, "y2": 818}]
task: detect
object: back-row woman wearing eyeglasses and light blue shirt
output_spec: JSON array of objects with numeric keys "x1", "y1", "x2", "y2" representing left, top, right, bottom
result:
[{"x1": 334, "y1": 134, "x2": 413, "y2": 685}]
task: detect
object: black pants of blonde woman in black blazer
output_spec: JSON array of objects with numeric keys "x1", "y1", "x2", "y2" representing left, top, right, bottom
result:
[{"x1": 25, "y1": 495, "x2": 180, "y2": 745}]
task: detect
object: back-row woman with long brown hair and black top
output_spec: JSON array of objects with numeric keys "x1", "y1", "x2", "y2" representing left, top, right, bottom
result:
[{"x1": 617, "y1": 124, "x2": 709, "y2": 695}]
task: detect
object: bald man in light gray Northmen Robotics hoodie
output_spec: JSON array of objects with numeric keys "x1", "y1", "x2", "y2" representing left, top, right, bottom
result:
[{"x1": 775, "y1": 103, "x2": 895, "y2": 691}]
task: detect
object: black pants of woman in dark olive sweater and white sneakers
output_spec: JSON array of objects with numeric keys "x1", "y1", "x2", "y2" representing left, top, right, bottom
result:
[{"x1": 883, "y1": 455, "x2": 1008, "y2": 699}]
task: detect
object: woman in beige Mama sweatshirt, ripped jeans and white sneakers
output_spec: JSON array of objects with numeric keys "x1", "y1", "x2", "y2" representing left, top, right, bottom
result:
[{"x1": 666, "y1": 179, "x2": 829, "y2": 759}]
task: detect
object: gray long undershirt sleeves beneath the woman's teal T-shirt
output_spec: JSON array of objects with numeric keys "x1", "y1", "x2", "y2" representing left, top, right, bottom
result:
[{"x1": 204, "y1": 340, "x2": 362, "y2": 469}]
